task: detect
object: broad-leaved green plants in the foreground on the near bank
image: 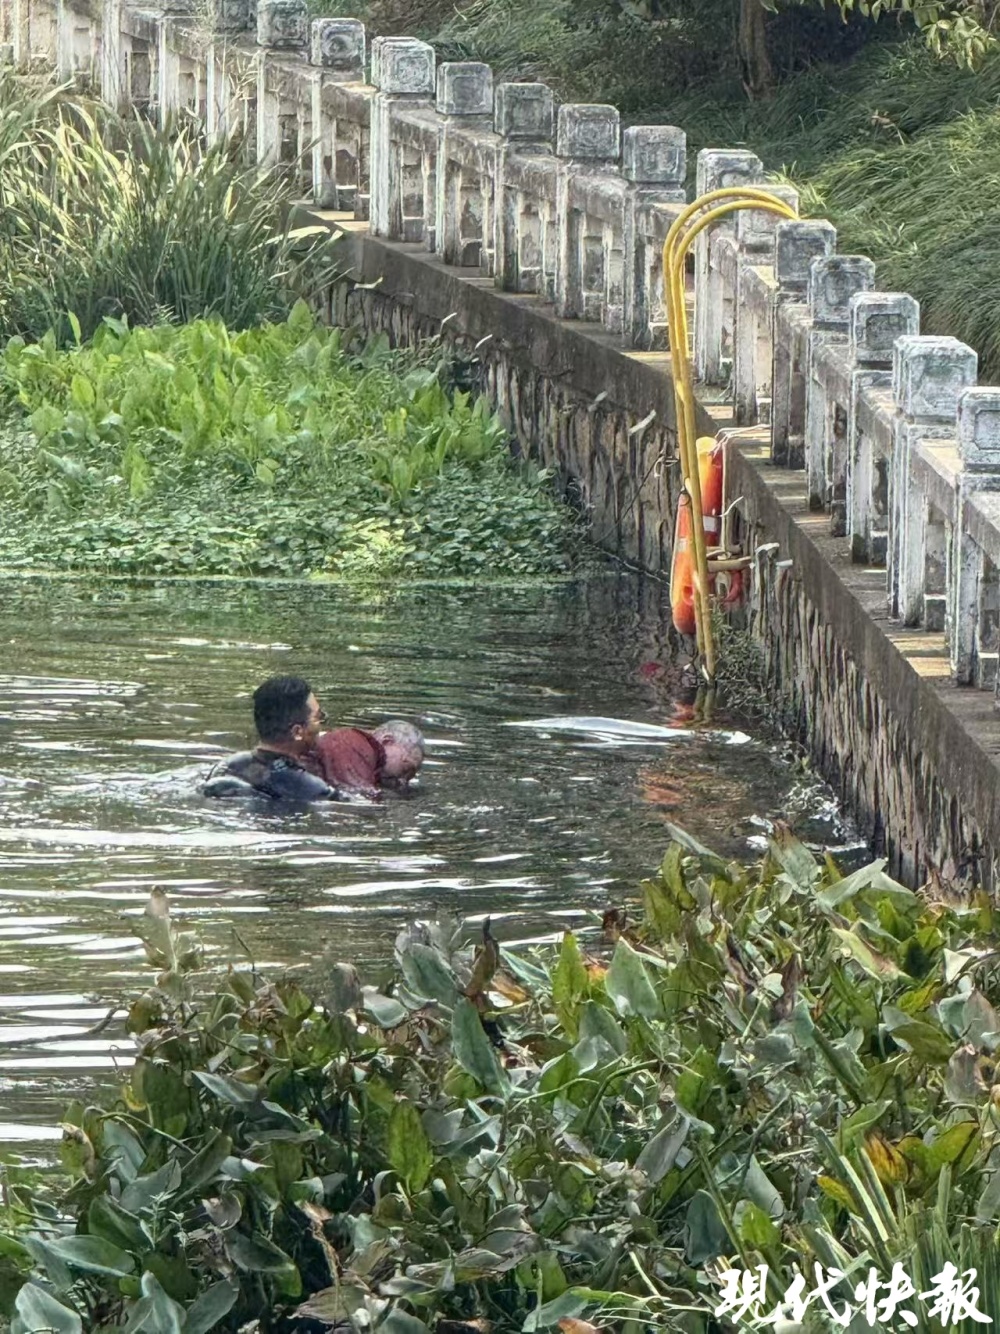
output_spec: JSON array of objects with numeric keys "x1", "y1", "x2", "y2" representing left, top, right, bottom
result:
[{"x1": 0, "y1": 828, "x2": 1000, "y2": 1334}]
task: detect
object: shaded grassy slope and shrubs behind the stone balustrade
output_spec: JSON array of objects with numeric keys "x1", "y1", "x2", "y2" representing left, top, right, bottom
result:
[{"x1": 313, "y1": 0, "x2": 1000, "y2": 382}]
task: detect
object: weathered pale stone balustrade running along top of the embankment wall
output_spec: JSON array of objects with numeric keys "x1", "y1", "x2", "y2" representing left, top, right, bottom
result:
[{"x1": 0, "y1": 0, "x2": 1000, "y2": 709}]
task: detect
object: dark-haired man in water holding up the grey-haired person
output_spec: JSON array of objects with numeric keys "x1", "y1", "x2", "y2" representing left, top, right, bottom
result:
[{"x1": 203, "y1": 676, "x2": 340, "y2": 802}]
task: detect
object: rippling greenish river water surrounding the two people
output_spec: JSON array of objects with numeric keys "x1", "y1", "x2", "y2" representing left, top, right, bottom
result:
[{"x1": 0, "y1": 575, "x2": 853, "y2": 1139}]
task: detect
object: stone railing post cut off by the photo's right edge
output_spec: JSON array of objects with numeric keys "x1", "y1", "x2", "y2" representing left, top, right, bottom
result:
[{"x1": 949, "y1": 387, "x2": 1000, "y2": 677}]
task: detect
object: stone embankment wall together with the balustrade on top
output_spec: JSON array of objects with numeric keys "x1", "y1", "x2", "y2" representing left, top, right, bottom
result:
[{"x1": 0, "y1": 0, "x2": 1000, "y2": 883}]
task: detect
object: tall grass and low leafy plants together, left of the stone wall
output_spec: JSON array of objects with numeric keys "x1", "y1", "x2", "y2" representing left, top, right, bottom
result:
[{"x1": 0, "y1": 71, "x2": 585, "y2": 583}]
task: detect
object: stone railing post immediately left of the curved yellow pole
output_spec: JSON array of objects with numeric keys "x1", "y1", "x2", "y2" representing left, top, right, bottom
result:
[{"x1": 621, "y1": 125, "x2": 688, "y2": 348}]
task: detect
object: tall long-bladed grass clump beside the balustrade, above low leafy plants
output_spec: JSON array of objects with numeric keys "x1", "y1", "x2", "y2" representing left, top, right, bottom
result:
[{"x1": 0, "y1": 71, "x2": 332, "y2": 342}]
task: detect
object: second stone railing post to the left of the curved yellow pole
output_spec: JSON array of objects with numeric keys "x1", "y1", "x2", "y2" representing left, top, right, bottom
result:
[{"x1": 556, "y1": 103, "x2": 621, "y2": 319}]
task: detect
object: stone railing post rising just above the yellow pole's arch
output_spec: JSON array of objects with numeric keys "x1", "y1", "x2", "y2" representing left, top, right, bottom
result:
[{"x1": 695, "y1": 148, "x2": 764, "y2": 384}]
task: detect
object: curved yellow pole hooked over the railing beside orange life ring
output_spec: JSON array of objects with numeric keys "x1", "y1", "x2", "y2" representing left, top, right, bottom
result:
[{"x1": 663, "y1": 185, "x2": 797, "y2": 682}]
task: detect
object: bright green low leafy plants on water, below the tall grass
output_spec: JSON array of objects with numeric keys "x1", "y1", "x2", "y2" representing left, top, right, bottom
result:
[{"x1": 0, "y1": 301, "x2": 585, "y2": 580}]
